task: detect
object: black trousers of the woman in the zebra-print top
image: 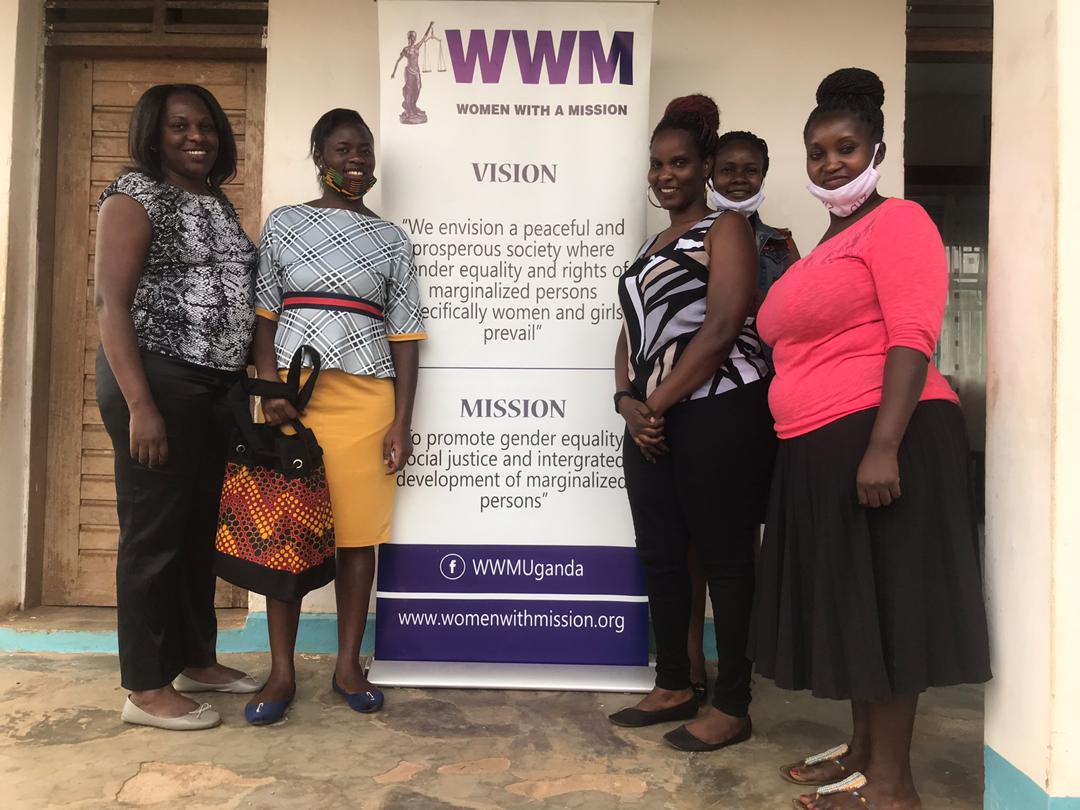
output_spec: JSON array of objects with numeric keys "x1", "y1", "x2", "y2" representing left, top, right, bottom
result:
[{"x1": 623, "y1": 381, "x2": 777, "y2": 717}]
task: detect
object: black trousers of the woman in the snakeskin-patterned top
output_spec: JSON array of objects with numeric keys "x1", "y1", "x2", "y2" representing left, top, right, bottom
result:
[{"x1": 97, "y1": 350, "x2": 241, "y2": 691}]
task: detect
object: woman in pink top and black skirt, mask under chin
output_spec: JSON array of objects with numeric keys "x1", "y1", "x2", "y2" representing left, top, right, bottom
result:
[{"x1": 752, "y1": 68, "x2": 990, "y2": 810}]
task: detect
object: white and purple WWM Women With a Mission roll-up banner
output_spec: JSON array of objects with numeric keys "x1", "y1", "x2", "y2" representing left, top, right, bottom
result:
[{"x1": 370, "y1": 0, "x2": 653, "y2": 690}]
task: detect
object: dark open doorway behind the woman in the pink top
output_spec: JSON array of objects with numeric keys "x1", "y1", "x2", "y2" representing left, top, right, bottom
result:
[{"x1": 904, "y1": 0, "x2": 994, "y2": 516}]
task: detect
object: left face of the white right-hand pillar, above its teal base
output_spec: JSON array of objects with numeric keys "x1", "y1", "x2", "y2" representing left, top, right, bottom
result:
[{"x1": 985, "y1": 0, "x2": 1058, "y2": 787}]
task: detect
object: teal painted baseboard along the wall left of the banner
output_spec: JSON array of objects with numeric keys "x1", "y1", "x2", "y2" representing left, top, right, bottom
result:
[{"x1": 0, "y1": 612, "x2": 375, "y2": 656}]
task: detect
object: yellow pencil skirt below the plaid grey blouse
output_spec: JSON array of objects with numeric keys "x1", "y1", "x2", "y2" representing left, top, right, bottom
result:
[{"x1": 279, "y1": 368, "x2": 397, "y2": 549}]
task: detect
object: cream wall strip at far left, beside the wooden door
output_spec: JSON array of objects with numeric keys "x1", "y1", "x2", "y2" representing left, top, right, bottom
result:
[{"x1": 0, "y1": 0, "x2": 43, "y2": 613}]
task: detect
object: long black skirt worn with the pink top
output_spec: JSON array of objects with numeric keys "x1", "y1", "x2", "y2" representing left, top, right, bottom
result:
[{"x1": 751, "y1": 401, "x2": 990, "y2": 701}]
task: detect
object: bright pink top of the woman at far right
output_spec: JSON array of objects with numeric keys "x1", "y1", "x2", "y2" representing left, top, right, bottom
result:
[{"x1": 757, "y1": 199, "x2": 959, "y2": 438}]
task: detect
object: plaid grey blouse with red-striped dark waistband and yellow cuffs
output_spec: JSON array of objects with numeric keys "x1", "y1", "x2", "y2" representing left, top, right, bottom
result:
[{"x1": 255, "y1": 204, "x2": 427, "y2": 377}]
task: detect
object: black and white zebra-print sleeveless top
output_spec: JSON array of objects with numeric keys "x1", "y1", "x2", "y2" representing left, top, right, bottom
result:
[{"x1": 619, "y1": 212, "x2": 768, "y2": 400}]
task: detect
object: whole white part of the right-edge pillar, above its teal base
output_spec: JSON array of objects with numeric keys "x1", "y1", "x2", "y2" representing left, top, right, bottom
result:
[{"x1": 986, "y1": 0, "x2": 1080, "y2": 796}]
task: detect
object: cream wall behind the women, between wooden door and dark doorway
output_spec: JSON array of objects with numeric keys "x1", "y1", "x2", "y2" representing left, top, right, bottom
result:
[{"x1": 261, "y1": 0, "x2": 906, "y2": 610}]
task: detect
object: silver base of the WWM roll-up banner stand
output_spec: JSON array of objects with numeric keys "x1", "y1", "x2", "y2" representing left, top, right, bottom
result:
[{"x1": 367, "y1": 660, "x2": 656, "y2": 692}]
